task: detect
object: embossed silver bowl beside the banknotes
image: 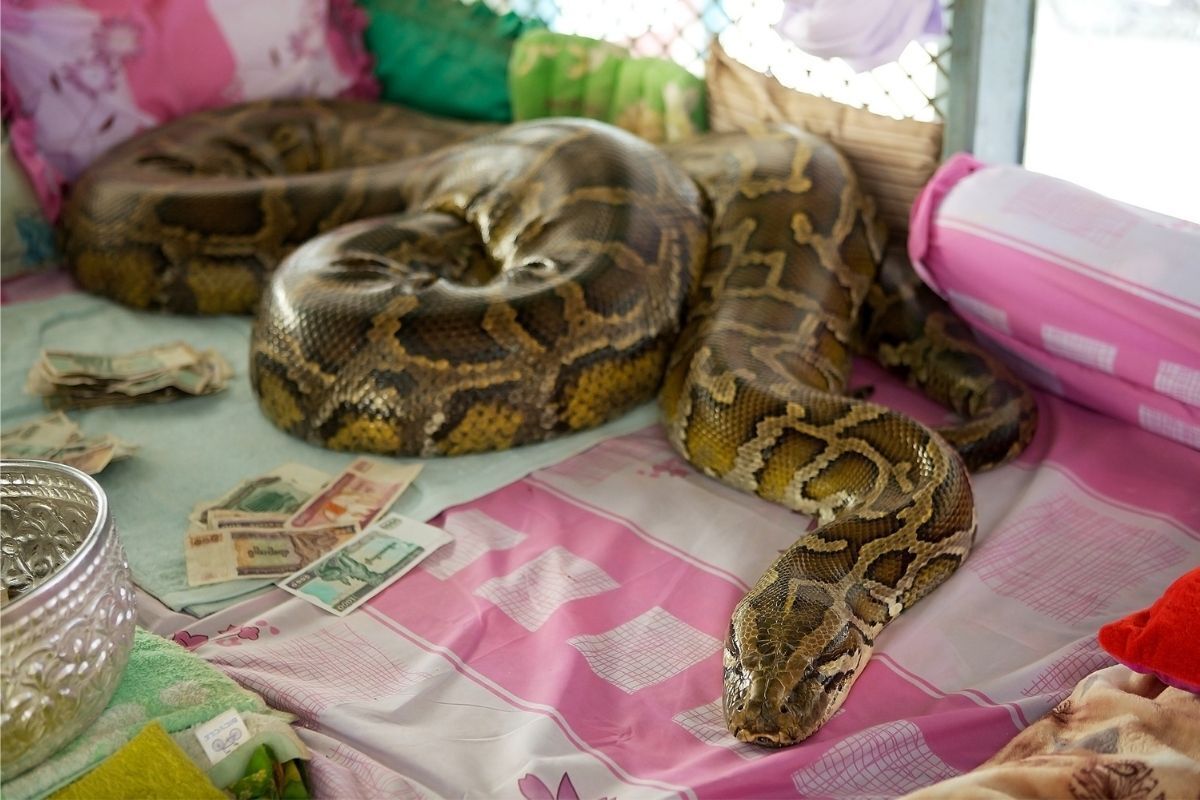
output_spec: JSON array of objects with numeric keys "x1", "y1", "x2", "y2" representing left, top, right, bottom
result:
[{"x1": 0, "y1": 461, "x2": 134, "y2": 781}]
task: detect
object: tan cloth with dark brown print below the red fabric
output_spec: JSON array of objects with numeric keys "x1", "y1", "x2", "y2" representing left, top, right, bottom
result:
[{"x1": 905, "y1": 664, "x2": 1200, "y2": 800}]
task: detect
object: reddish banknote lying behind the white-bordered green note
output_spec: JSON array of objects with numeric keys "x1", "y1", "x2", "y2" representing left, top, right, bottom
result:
[{"x1": 288, "y1": 458, "x2": 421, "y2": 528}]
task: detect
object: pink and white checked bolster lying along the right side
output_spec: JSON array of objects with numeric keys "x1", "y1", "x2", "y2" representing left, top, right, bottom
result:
[{"x1": 908, "y1": 154, "x2": 1200, "y2": 449}]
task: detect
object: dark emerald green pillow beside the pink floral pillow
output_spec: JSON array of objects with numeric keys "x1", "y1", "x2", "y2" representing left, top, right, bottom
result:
[{"x1": 359, "y1": 0, "x2": 540, "y2": 122}]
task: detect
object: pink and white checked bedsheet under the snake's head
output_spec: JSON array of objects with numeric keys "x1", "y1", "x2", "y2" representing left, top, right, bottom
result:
[{"x1": 158, "y1": 368, "x2": 1200, "y2": 800}]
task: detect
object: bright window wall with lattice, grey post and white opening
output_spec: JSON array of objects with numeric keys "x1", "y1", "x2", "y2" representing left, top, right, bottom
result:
[{"x1": 485, "y1": 0, "x2": 1200, "y2": 222}]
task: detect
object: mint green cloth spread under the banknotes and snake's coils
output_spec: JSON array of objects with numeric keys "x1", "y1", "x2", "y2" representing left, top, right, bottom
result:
[{"x1": 0, "y1": 293, "x2": 658, "y2": 616}]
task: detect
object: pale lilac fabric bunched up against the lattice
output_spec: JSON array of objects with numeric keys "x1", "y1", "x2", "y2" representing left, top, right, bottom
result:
[{"x1": 775, "y1": 0, "x2": 946, "y2": 72}]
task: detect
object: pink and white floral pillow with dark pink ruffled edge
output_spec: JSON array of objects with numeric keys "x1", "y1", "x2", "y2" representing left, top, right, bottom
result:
[{"x1": 0, "y1": 0, "x2": 378, "y2": 219}]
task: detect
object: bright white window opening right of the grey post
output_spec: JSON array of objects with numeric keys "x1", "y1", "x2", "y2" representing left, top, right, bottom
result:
[{"x1": 1024, "y1": 0, "x2": 1200, "y2": 222}]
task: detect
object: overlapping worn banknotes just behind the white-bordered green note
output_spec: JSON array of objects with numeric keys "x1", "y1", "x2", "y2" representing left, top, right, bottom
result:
[{"x1": 184, "y1": 458, "x2": 421, "y2": 587}]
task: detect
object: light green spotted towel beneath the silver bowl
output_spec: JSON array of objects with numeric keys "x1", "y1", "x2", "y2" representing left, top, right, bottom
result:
[{"x1": 0, "y1": 628, "x2": 294, "y2": 800}]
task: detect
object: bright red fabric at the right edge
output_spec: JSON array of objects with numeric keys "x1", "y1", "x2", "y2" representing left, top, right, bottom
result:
[{"x1": 1099, "y1": 569, "x2": 1200, "y2": 693}]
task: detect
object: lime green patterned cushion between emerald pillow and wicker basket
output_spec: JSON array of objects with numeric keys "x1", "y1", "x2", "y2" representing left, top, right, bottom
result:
[{"x1": 509, "y1": 30, "x2": 708, "y2": 143}]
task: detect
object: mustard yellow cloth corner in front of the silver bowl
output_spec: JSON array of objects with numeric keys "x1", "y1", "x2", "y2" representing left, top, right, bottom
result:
[{"x1": 50, "y1": 722, "x2": 226, "y2": 800}]
